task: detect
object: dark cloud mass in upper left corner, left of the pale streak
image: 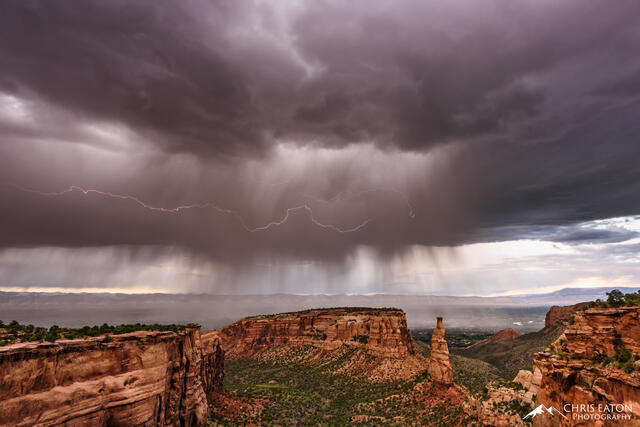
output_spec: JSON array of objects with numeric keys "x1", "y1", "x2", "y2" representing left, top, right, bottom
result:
[{"x1": 0, "y1": 1, "x2": 261, "y2": 156}]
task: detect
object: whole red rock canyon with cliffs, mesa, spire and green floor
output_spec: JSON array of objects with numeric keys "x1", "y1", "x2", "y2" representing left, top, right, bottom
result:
[{"x1": 0, "y1": 304, "x2": 640, "y2": 426}]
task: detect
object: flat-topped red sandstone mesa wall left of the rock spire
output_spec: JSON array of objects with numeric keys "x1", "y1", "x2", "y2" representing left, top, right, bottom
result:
[{"x1": 215, "y1": 307, "x2": 416, "y2": 358}]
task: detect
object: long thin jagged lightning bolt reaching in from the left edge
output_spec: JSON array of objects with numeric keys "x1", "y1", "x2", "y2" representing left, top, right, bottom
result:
[{"x1": 4, "y1": 183, "x2": 371, "y2": 233}]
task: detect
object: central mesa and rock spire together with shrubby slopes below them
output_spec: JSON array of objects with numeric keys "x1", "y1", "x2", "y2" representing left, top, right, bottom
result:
[{"x1": 210, "y1": 308, "x2": 475, "y2": 426}]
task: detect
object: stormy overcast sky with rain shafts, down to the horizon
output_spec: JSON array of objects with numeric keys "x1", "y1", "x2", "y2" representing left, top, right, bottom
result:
[{"x1": 0, "y1": 0, "x2": 640, "y2": 295}]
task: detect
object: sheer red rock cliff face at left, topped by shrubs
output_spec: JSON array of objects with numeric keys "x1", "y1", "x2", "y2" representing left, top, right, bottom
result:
[{"x1": 0, "y1": 325, "x2": 224, "y2": 426}]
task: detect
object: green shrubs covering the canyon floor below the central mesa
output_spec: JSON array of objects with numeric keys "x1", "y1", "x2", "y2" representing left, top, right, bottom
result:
[{"x1": 211, "y1": 347, "x2": 471, "y2": 426}]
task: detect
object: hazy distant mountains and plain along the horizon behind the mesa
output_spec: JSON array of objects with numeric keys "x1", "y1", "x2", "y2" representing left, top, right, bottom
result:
[{"x1": 0, "y1": 287, "x2": 639, "y2": 332}]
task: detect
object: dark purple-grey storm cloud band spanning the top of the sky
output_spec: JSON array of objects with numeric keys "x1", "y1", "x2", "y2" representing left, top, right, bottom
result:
[{"x1": 0, "y1": 1, "x2": 638, "y2": 154}]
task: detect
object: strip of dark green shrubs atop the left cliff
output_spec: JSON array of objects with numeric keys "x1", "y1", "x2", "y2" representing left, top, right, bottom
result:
[{"x1": 0, "y1": 320, "x2": 186, "y2": 346}]
